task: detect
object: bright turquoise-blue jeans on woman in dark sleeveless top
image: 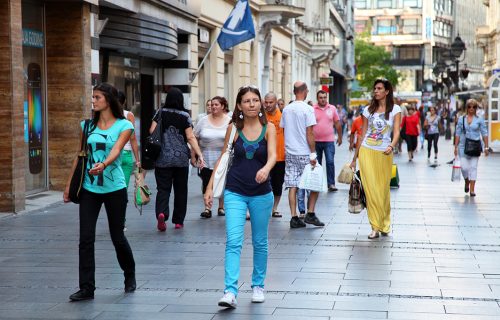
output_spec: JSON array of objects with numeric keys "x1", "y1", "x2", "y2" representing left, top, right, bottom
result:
[{"x1": 224, "y1": 190, "x2": 274, "y2": 295}]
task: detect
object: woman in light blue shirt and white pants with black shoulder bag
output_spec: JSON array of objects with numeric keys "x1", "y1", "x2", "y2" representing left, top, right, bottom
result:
[{"x1": 454, "y1": 99, "x2": 488, "y2": 197}]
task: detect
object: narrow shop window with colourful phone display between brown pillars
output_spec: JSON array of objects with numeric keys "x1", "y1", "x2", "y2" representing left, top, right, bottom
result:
[{"x1": 22, "y1": 0, "x2": 48, "y2": 194}]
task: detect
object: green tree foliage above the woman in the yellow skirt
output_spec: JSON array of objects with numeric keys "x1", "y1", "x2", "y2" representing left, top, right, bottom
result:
[{"x1": 354, "y1": 37, "x2": 400, "y2": 90}]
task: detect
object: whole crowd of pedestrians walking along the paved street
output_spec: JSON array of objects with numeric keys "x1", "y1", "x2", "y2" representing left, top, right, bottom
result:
[{"x1": 64, "y1": 79, "x2": 488, "y2": 308}]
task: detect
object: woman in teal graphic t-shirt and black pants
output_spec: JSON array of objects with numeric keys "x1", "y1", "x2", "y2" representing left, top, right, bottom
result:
[{"x1": 64, "y1": 83, "x2": 136, "y2": 301}]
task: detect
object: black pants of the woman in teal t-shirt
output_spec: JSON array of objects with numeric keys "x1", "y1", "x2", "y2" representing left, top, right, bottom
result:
[{"x1": 79, "y1": 188, "x2": 135, "y2": 291}]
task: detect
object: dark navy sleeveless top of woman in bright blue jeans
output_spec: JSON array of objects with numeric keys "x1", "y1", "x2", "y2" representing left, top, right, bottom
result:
[{"x1": 226, "y1": 126, "x2": 272, "y2": 197}]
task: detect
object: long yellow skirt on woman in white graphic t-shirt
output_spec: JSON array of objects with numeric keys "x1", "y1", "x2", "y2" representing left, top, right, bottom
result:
[{"x1": 359, "y1": 147, "x2": 393, "y2": 232}]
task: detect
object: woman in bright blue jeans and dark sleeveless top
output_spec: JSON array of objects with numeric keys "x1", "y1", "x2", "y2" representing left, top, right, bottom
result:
[{"x1": 205, "y1": 86, "x2": 276, "y2": 308}]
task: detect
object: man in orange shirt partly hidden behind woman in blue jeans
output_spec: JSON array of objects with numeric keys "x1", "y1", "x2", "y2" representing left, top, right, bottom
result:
[{"x1": 264, "y1": 92, "x2": 285, "y2": 218}]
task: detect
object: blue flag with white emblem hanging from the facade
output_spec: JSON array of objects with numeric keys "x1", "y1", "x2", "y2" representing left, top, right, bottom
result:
[{"x1": 217, "y1": 0, "x2": 255, "y2": 51}]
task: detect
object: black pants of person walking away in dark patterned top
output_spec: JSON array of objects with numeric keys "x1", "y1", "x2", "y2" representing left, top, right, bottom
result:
[{"x1": 155, "y1": 167, "x2": 189, "y2": 224}]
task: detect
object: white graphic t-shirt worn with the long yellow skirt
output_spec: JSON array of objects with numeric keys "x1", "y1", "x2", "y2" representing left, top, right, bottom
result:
[{"x1": 362, "y1": 104, "x2": 401, "y2": 151}]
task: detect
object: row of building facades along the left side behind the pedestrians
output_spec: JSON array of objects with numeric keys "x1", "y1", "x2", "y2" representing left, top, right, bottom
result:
[{"x1": 0, "y1": 0, "x2": 354, "y2": 212}]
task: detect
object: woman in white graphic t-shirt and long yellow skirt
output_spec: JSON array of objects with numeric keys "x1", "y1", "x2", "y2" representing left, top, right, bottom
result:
[{"x1": 351, "y1": 79, "x2": 401, "y2": 239}]
